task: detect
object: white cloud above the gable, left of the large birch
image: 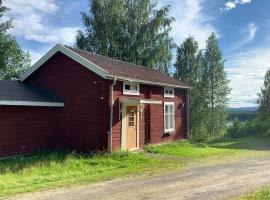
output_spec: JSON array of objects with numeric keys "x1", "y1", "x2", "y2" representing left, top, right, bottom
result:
[{"x1": 4, "y1": 0, "x2": 79, "y2": 44}]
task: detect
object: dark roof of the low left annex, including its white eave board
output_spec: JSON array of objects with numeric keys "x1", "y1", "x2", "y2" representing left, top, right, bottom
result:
[{"x1": 0, "y1": 80, "x2": 64, "y2": 107}]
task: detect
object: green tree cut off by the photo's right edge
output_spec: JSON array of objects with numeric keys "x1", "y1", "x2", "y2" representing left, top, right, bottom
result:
[{"x1": 258, "y1": 69, "x2": 270, "y2": 120}]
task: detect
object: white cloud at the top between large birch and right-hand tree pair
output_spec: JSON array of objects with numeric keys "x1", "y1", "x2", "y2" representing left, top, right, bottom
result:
[{"x1": 159, "y1": 0, "x2": 217, "y2": 48}]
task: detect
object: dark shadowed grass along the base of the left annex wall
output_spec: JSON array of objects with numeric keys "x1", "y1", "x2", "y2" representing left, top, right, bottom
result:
[{"x1": 0, "y1": 150, "x2": 70, "y2": 174}]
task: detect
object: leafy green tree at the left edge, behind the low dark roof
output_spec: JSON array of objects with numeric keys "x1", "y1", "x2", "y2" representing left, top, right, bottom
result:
[{"x1": 0, "y1": 0, "x2": 30, "y2": 80}]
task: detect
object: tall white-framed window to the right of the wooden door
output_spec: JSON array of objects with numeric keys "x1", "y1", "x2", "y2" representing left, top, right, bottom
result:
[{"x1": 164, "y1": 102, "x2": 175, "y2": 133}]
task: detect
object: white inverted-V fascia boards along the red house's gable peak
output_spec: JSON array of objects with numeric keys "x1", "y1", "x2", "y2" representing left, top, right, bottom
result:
[{"x1": 21, "y1": 44, "x2": 108, "y2": 81}]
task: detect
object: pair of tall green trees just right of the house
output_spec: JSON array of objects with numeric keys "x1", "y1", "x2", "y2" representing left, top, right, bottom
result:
[{"x1": 174, "y1": 34, "x2": 230, "y2": 140}]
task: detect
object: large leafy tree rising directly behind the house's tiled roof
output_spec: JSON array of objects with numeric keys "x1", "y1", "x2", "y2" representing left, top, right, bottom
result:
[{"x1": 76, "y1": 0, "x2": 174, "y2": 73}]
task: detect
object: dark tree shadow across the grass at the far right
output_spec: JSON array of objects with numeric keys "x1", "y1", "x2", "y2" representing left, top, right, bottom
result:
[{"x1": 209, "y1": 136, "x2": 270, "y2": 151}]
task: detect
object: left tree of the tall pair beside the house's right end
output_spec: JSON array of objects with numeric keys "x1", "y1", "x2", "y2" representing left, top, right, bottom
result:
[{"x1": 174, "y1": 37, "x2": 209, "y2": 140}]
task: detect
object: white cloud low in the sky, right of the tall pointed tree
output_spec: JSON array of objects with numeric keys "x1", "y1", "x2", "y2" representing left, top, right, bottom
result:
[{"x1": 226, "y1": 48, "x2": 270, "y2": 107}]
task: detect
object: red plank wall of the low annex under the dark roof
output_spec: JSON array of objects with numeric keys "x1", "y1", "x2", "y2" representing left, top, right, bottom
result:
[{"x1": 0, "y1": 106, "x2": 61, "y2": 157}]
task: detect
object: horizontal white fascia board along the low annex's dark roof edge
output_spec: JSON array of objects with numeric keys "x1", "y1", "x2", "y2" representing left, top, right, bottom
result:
[{"x1": 0, "y1": 100, "x2": 65, "y2": 107}]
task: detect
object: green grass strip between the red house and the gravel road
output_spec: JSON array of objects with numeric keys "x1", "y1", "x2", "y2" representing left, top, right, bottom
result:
[{"x1": 0, "y1": 137, "x2": 270, "y2": 197}]
